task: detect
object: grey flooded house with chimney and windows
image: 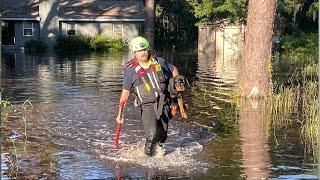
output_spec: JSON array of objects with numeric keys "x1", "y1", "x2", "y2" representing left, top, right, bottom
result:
[{"x1": 1, "y1": 0, "x2": 145, "y2": 49}]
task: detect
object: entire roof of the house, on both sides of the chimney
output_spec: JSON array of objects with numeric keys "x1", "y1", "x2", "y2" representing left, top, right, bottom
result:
[{"x1": 0, "y1": 0, "x2": 145, "y2": 21}]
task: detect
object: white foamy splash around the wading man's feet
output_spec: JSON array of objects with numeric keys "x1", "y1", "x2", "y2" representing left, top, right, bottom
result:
[{"x1": 100, "y1": 139, "x2": 209, "y2": 172}]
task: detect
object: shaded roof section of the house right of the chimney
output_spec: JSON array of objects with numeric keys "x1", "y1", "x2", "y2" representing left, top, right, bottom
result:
[{"x1": 59, "y1": 0, "x2": 145, "y2": 21}]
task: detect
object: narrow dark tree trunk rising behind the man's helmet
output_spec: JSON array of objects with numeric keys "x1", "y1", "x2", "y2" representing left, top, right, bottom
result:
[{"x1": 145, "y1": 0, "x2": 155, "y2": 49}]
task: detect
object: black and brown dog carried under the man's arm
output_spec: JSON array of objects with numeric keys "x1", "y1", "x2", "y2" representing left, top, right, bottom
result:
[{"x1": 168, "y1": 75, "x2": 188, "y2": 121}]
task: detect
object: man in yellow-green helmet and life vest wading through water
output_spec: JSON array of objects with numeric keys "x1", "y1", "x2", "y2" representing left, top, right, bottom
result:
[{"x1": 116, "y1": 36, "x2": 179, "y2": 156}]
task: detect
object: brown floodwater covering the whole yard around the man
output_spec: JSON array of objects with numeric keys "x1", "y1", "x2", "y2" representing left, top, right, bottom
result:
[{"x1": 1, "y1": 52, "x2": 320, "y2": 179}]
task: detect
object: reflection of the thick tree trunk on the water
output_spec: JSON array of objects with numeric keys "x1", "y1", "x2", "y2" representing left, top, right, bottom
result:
[{"x1": 239, "y1": 99, "x2": 271, "y2": 179}]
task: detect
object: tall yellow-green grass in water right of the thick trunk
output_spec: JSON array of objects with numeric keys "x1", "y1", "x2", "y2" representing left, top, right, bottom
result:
[{"x1": 270, "y1": 62, "x2": 320, "y2": 157}]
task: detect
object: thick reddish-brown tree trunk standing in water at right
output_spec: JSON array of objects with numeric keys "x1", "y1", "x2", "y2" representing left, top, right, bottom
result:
[{"x1": 238, "y1": 0, "x2": 276, "y2": 98}]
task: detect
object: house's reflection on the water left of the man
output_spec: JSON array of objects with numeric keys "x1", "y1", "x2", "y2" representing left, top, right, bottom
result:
[{"x1": 2, "y1": 51, "x2": 127, "y2": 102}]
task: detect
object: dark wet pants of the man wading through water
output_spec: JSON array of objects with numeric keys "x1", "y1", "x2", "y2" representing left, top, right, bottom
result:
[{"x1": 141, "y1": 104, "x2": 169, "y2": 155}]
